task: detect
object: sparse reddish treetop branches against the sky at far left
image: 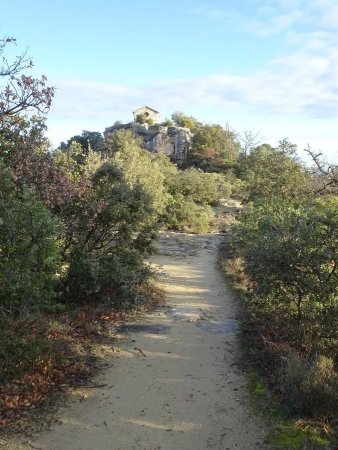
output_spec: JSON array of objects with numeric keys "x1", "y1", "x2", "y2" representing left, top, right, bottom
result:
[{"x1": 0, "y1": 37, "x2": 54, "y2": 125}]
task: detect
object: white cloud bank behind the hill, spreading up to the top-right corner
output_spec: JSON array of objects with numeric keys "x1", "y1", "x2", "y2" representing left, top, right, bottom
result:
[{"x1": 45, "y1": 0, "x2": 338, "y2": 162}]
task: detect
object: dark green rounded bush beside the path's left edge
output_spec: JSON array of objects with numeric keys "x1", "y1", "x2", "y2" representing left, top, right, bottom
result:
[{"x1": 60, "y1": 156, "x2": 157, "y2": 307}]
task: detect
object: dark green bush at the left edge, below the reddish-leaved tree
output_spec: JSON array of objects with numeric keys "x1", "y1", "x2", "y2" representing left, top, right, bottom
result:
[{"x1": 0, "y1": 163, "x2": 60, "y2": 311}]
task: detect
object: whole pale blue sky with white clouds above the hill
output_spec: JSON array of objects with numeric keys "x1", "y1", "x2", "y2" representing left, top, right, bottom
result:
[{"x1": 0, "y1": 0, "x2": 338, "y2": 163}]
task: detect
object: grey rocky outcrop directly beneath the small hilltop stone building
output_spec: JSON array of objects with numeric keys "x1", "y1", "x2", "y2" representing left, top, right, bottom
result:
[{"x1": 104, "y1": 122, "x2": 192, "y2": 164}]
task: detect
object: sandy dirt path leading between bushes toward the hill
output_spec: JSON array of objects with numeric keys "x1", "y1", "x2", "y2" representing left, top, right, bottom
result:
[{"x1": 8, "y1": 234, "x2": 265, "y2": 450}]
